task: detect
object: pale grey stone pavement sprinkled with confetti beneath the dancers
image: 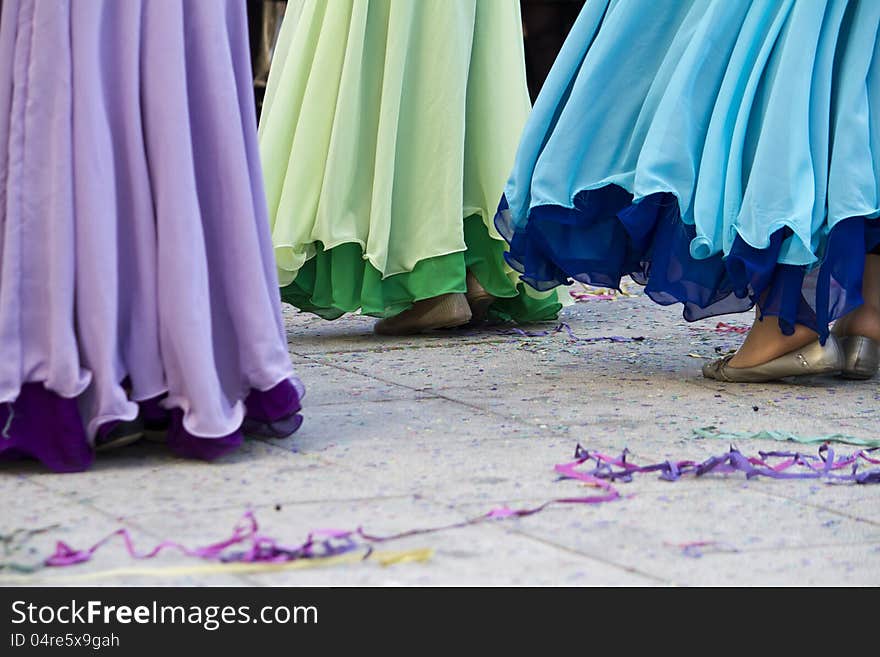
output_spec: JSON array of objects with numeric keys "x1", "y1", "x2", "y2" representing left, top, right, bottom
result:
[{"x1": 0, "y1": 284, "x2": 880, "y2": 586}]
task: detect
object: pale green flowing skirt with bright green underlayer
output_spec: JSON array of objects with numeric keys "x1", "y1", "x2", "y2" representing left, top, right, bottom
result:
[{"x1": 260, "y1": 0, "x2": 560, "y2": 321}]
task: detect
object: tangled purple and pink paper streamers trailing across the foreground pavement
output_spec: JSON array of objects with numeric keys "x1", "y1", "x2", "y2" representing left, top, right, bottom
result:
[{"x1": 37, "y1": 445, "x2": 880, "y2": 566}]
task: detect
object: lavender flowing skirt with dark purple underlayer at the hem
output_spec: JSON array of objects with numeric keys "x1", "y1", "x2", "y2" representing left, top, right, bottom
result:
[{"x1": 0, "y1": 0, "x2": 303, "y2": 471}]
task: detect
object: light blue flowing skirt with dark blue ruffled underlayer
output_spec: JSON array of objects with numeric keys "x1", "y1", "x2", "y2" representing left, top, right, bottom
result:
[{"x1": 496, "y1": 0, "x2": 880, "y2": 338}]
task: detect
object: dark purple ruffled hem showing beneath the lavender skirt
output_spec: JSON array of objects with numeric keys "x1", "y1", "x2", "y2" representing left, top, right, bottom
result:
[{"x1": 0, "y1": 379, "x2": 303, "y2": 472}]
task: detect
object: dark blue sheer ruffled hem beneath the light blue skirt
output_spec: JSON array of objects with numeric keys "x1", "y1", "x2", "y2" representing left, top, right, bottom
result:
[{"x1": 495, "y1": 185, "x2": 880, "y2": 341}]
